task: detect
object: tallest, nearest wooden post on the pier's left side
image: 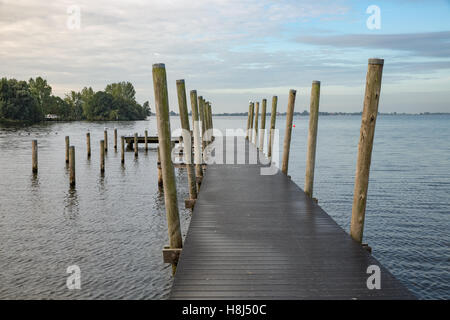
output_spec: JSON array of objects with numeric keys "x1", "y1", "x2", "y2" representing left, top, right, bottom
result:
[{"x1": 153, "y1": 63, "x2": 183, "y2": 273}]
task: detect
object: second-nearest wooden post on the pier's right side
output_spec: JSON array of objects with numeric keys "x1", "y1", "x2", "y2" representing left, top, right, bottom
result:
[{"x1": 305, "y1": 80, "x2": 320, "y2": 198}]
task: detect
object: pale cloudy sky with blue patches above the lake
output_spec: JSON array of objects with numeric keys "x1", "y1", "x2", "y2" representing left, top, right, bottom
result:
[{"x1": 0, "y1": 0, "x2": 450, "y2": 113}]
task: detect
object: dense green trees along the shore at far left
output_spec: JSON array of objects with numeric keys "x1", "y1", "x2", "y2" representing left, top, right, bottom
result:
[{"x1": 0, "y1": 77, "x2": 151, "y2": 123}]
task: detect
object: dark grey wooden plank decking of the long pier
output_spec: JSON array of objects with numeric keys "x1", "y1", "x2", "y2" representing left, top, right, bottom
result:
[{"x1": 170, "y1": 138, "x2": 414, "y2": 299}]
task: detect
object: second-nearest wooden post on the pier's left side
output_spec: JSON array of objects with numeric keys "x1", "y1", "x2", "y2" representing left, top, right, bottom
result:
[{"x1": 177, "y1": 80, "x2": 197, "y2": 208}]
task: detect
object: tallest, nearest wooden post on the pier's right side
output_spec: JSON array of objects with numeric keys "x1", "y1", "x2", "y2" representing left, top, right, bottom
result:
[{"x1": 350, "y1": 59, "x2": 384, "y2": 243}]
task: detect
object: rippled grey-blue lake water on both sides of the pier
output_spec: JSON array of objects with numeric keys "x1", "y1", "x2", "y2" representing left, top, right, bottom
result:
[{"x1": 0, "y1": 115, "x2": 450, "y2": 299}]
